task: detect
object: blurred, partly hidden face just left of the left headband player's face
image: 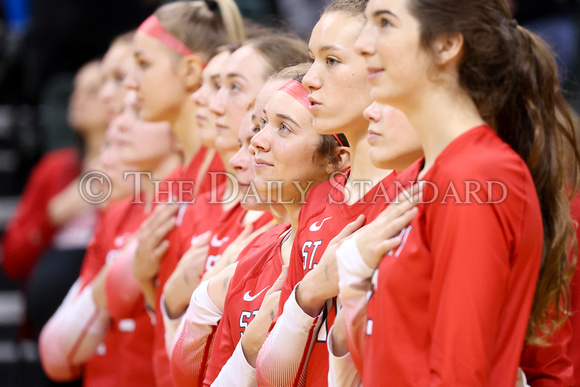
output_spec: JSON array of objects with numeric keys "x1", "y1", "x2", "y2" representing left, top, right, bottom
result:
[{"x1": 99, "y1": 43, "x2": 133, "y2": 122}]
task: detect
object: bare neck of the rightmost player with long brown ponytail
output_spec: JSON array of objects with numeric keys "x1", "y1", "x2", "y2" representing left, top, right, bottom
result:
[{"x1": 400, "y1": 87, "x2": 485, "y2": 175}]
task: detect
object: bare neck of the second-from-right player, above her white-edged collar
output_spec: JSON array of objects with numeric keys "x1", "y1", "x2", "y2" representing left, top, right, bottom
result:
[{"x1": 346, "y1": 127, "x2": 392, "y2": 204}]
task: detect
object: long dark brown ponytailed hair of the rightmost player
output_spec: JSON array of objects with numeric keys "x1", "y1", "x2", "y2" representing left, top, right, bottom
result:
[{"x1": 409, "y1": 0, "x2": 580, "y2": 344}]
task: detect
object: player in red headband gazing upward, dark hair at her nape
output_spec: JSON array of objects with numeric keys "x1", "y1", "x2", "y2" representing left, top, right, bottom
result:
[{"x1": 204, "y1": 81, "x2": 349, "y2": 386}]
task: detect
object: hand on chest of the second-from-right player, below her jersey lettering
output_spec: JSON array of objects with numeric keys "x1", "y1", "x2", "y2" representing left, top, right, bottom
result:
[{"x1": 296, "y1": 215, "x2": 365, "y2": 317}]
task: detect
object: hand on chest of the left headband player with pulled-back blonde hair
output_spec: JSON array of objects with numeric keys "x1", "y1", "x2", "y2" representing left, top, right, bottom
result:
[{"x1": 133, "y1": 203, "x2": 179, "y2": 283}]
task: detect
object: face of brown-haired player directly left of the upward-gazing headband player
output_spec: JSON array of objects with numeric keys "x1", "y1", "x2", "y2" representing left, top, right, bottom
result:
[{"x1": 210, "y1": 46, "x2": 269, "y2": 140}]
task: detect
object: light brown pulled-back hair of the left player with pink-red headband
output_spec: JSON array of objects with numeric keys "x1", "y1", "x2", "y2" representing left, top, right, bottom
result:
[{"x1": 155, "y1": 0, "x2": 245, "y2": 62}]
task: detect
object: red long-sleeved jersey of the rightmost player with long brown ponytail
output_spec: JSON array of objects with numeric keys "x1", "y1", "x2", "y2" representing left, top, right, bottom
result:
[{"x1": 363, "y1": 126, "x2": 543, "y2": 387}]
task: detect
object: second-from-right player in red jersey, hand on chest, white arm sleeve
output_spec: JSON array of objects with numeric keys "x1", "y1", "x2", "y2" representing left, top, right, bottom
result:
[{"x1": 257, "y1": 0, "x2": 421, "y2": 386}]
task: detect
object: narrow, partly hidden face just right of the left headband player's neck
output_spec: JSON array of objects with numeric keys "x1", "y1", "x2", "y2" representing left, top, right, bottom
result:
[{"x1": 191, "y1": 51, "x2": 230, "y2": 148}]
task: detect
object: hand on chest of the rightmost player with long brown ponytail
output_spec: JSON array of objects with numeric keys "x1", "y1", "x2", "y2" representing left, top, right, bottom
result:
[{"x1": 356, "y1": 184, "x2": 422, "y2": 269}]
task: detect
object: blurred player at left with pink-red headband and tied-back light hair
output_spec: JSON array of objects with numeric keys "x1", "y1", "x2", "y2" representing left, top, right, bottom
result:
[{"x1": 92, "y1": 0, "x2": 248, "y2": 385}]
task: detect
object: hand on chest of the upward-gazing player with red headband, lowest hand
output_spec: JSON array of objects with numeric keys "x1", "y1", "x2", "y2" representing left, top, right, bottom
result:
[{"x1": 242, "y1": 265, "x2": 288, "y2": 368}]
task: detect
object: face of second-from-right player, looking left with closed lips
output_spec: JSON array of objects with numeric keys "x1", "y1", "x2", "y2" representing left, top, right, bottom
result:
[{"x1": 302, "y1": 12, "x2": 372, "y2": 137}]
